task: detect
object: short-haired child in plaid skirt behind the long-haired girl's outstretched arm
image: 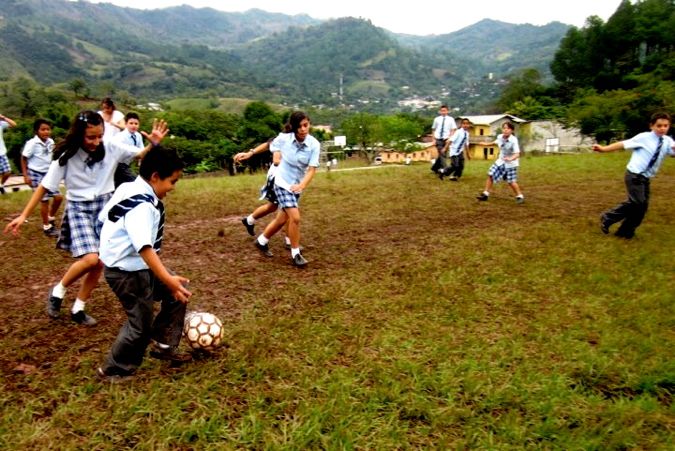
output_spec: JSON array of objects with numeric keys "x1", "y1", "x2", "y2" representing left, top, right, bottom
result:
[{"x1": 21, "y1": 119, "x2": 63, "y2": 237}]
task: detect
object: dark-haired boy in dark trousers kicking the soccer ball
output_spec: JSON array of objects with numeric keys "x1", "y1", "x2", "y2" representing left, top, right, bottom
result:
[{"x1": 97, "y1": 146, "x2": 191, "y2": 381}]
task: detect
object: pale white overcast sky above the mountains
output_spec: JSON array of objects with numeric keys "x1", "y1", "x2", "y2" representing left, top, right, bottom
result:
[{"x1": 90, "y1": 0, "x2": 621, "y2": 35}]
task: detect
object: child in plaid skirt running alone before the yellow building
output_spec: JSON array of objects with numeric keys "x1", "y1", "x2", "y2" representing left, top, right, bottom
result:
[{"x1": 477, "y1": 122, "x2": 525, "y2": 204}]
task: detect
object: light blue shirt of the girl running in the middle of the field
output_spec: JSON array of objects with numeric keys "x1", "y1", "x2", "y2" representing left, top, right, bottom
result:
[{"x1": 270, "y1": 133, "x2": 321, "y2": 189}]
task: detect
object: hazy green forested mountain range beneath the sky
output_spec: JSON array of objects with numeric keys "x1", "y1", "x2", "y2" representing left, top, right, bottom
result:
[{"x1": 0, "y1": 0, "x2": 567, "y2": 110}]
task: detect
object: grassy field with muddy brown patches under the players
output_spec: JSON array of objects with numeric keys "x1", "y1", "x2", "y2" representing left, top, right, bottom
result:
[{"x1": 0, "y1": 153, "x2": 675, "y2": 450}]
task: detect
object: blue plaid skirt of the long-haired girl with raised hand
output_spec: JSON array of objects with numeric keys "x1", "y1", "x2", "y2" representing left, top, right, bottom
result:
[{"x1": 56, "y1": 193, "x2": 113, "y2": 258}]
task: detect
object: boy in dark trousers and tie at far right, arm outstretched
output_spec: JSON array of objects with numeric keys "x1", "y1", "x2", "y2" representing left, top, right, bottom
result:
[{"x1": 593, "y1": 113, "x2": 675, "y2": 239}]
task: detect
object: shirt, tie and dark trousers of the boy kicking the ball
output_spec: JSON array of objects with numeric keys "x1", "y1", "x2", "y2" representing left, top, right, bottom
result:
[{"x1": 98, "y1": 176, "x2": 187, "y2": 375}]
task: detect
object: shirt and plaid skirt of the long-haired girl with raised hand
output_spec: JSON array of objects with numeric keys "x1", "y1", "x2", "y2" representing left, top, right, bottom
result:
[{"x1": 40, "y1": 140, "x2": 141, "y2": 257}]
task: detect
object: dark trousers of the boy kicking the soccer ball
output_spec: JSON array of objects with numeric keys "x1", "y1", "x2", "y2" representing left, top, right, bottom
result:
[{"x1": 103, "y1": 267, "x2": 187, "y2": 375}]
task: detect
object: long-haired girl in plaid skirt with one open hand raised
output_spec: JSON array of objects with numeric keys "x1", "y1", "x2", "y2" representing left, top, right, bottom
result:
[{"x1": 5, "y1": 111, "x2": 168, "y2": 326}]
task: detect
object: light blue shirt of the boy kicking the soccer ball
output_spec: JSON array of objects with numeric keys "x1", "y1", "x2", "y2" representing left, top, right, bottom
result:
[{"x1": 98, "y1": 176, "x2": 161, "y2": 271}]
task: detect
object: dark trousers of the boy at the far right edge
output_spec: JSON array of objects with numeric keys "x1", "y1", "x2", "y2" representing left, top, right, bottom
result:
[{"x1": 602, "y1": 171, "x2": 649, "y2": 238}]
